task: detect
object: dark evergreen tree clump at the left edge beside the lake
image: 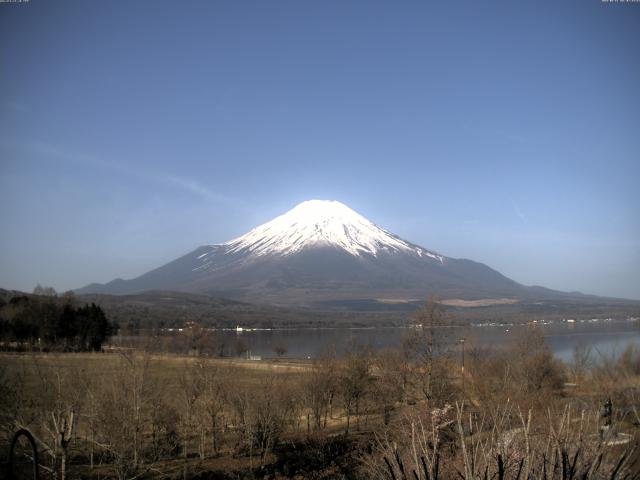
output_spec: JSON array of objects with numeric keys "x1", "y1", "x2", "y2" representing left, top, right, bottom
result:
[{"x1": 0, "y1": 286, "x2": 118, "y2": 351}]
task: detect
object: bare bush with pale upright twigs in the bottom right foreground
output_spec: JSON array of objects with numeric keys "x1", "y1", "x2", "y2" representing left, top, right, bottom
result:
[{"x1": 365, "y1": 404, "x2": 637, "y2": 480}]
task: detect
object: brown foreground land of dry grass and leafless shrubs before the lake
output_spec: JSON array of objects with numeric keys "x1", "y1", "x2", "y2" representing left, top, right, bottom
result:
[{"x1": 0, "y1": 320, "x2": 640, "y2": 480}]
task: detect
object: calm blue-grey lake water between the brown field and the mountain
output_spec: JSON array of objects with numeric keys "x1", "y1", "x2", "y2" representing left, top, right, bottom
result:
[{"x1": 212, "y1": 320, "x2": 640, "y2": 361}]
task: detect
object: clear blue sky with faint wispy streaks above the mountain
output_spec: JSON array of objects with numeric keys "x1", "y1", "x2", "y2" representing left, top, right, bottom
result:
[{"x1": 0, "y1": 0, "x2": 640, "y2": 299}]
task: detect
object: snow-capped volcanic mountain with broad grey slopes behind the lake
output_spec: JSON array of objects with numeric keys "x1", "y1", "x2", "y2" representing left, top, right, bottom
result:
[{"x1": 77, "y1": 200, "x2": 562, "y2": 305}]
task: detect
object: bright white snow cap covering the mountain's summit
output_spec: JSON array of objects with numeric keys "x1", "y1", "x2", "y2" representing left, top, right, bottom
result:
[{"x1": 221, "y1": 200, "x2": 443, "y2": 262}]
